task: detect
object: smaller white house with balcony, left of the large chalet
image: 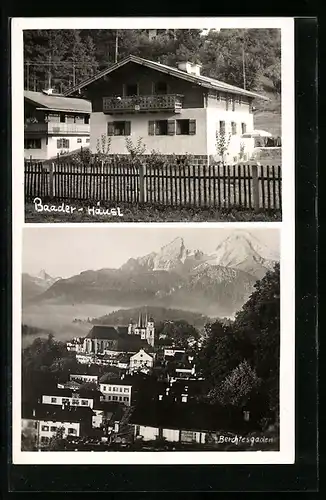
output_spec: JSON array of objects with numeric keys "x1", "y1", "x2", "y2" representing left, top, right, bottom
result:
[{"x1": 24, "y1": 89, "x2": 91, "y2": 160}]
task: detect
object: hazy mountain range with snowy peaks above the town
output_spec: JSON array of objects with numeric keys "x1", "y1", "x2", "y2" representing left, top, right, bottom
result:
[{"x1": 23, "y1": 231, "x2": 278, "y2": 316}]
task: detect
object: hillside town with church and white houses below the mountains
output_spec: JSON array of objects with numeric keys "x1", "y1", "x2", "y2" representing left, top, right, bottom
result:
[{"x1": 22, "y1": 266, "x2": 278, "y2": 451}]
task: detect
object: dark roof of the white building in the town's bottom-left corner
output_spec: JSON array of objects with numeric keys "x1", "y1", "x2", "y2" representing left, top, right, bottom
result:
[{"x1": 22, "y1": 404, "x2": 95, "y2": 422}]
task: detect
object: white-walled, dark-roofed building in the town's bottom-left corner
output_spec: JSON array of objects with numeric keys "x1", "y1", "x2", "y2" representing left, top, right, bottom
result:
[{"x1": 22, "y1": 404, "x2": 94, "y2": 448}]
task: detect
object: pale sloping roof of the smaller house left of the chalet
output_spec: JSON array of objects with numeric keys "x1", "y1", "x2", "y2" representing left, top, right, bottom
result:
[{"x1": 24, "y1": 90, "x2": 91, "y2": 113}]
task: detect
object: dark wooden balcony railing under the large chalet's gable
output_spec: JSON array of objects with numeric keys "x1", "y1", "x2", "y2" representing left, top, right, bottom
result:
[{"x1": 103, "y1": 94, "x2": 183, "y2": 114}]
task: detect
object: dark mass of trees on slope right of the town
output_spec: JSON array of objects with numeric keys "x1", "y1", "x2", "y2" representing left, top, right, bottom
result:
[{"x1": 198, "y1": 264, "x2": 280, "y2": 423}]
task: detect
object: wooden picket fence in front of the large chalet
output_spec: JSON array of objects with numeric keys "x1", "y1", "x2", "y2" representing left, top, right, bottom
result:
[{"x1": 25, "y1": 161, "x2": 282, "y2": 210}]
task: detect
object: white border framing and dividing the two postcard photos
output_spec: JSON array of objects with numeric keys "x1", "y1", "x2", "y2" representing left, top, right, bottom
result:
[{"x1": 11, "y1": 17, "x2": 295, "y2": 465}]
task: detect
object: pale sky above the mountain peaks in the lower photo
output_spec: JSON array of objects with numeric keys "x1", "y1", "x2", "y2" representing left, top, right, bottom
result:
[{"x1": 22, "y1": 224, "x2": 279, "y2": 278}]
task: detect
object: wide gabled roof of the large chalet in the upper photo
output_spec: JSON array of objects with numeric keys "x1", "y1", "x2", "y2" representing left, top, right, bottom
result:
[{"x1": 63, "y1": 55, "x2": 269, "y2": 101}]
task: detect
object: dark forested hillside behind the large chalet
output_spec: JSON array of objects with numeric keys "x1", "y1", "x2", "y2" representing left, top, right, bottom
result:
[{"x1": 24, "y1": 29, "x2": 281, "y2": 101}]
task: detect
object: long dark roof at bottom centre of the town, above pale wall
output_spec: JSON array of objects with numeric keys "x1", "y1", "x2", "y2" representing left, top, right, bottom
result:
[{"x1": 130, "y1": 399, "x2": 249, "y2": 432}]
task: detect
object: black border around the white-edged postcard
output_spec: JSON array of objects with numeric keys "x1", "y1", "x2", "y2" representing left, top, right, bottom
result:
[{"x1": 1, "y1": 13, "x2": 318, "y2": 493}]
